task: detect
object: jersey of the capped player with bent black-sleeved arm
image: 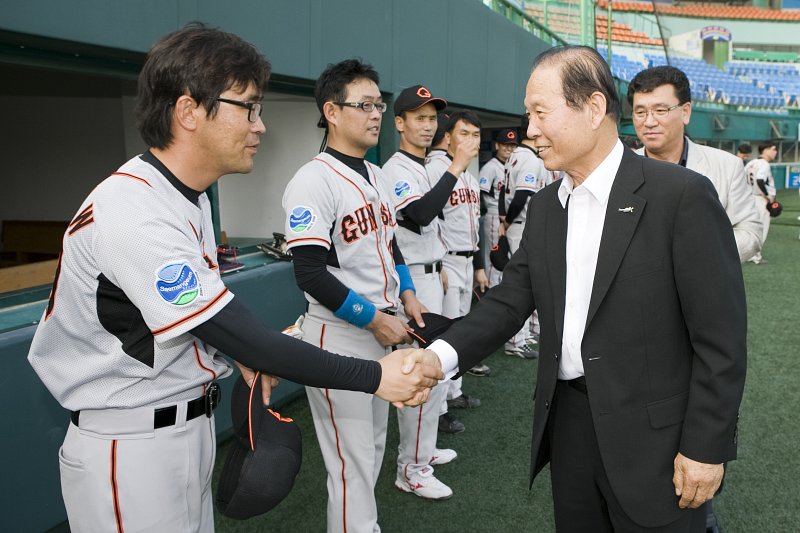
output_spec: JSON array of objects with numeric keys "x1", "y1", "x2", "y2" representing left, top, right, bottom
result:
[{"x1": 380, "y1": 152, "x2": 447, "y2": 265}]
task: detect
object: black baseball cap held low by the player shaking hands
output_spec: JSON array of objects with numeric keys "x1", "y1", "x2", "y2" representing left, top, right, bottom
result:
[{"x1": 217, "y1": 373, "x2": 303, "y2": 520}]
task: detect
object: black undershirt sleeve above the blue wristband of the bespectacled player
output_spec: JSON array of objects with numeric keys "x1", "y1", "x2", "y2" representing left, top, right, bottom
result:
[{"x1": 292, "y1": 244, "x2": 350, "y2": 312}]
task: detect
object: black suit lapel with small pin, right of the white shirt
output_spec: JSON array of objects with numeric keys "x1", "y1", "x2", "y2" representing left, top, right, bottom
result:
[{"x1": 586, "y1": 148, "x2": 647, "y2": 329}]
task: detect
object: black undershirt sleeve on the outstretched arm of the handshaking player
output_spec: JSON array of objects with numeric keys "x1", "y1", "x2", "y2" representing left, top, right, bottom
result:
[{"x1": 191, "y1": 298, "x2": 381, "y2": 394}]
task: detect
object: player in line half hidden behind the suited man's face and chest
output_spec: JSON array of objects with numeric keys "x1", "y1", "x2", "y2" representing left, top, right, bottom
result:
[{"x1": 500, "y1": 115, "x2": 551, "y2": 359}]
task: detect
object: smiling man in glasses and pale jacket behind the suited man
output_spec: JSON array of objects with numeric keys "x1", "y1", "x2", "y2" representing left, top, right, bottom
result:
[{"x1": 628, "y1": 66, "x2": 762, "y2": 262}]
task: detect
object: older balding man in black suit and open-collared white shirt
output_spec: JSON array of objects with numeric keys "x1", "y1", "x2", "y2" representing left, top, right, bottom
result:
[{"x1": 422, "y1": 47, "x2": 747, "y2": 532}]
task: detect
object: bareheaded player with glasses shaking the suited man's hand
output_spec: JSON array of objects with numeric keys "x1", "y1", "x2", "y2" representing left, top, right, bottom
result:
[{"x1": 28, "y1": 24, "x2": 441, "y2": 532}]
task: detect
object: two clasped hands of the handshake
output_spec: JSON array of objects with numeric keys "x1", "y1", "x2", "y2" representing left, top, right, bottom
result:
[{"x1": 375, "y1": 348, "x2": 444, "y2": 409}]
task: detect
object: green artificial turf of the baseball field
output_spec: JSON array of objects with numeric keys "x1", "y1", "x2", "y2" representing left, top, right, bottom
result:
[{"x1": 214, "y1": 191, "x2": 800, "y2": 533}]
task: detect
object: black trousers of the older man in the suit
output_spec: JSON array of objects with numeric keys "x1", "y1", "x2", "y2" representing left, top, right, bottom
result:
[{"x1": 547, "y1": 382, "x2": 706, "y2": 533}]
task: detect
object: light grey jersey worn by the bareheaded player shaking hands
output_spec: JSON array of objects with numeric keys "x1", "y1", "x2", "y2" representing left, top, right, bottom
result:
[{"x1": 28, "y1": 157, "x2": 233, "y2": 411}]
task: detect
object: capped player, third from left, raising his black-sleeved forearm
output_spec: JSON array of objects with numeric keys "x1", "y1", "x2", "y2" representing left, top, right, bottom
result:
[{"x1": 382, "y1": 85, "x2": 474, "y2": 500}]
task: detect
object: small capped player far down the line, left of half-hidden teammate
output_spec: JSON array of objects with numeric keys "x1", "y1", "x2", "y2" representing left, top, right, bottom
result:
[{"x1": 478, "y1": 129, "x2": 517, "y2": 287}]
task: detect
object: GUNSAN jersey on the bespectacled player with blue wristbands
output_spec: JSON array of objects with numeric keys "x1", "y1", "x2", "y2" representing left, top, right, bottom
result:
[{"x1": 283, "y1": 152, "x2": 400, "y2": 312}]
